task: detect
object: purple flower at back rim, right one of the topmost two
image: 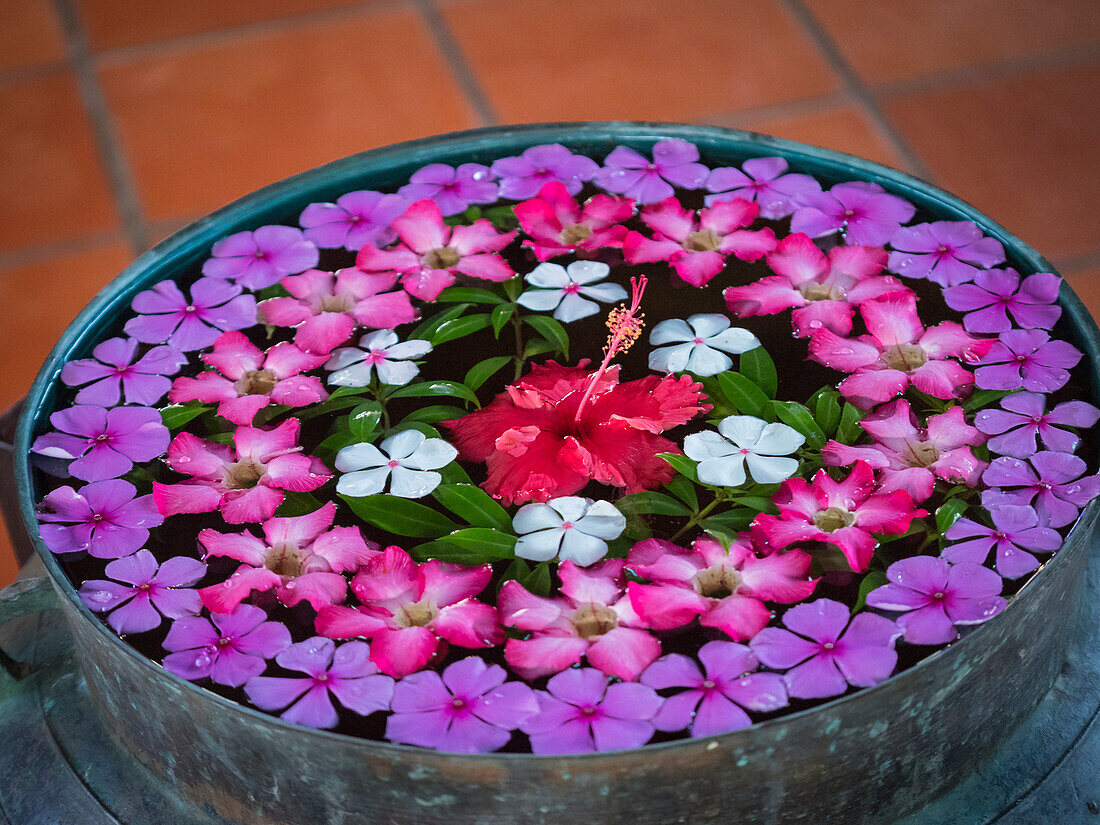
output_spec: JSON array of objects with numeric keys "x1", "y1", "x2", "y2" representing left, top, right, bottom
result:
[{"x1": 595, "y1": 139, "x2": 710, "y2": 204}]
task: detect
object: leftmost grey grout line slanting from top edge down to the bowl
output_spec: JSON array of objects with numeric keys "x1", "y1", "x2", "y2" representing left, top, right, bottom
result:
[{"x1": 54, "y1": 0, "x2": 149, "y2": 254}]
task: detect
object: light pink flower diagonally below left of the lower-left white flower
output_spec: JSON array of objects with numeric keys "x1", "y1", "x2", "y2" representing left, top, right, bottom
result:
[{"x1": 198, "y1": 502, "x2": 378, "y2": 613}]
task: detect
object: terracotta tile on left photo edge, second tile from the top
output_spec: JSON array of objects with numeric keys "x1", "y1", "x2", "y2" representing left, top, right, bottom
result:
[{"x1": 0, "y1": 74, "x2": 118, "y2": 251}]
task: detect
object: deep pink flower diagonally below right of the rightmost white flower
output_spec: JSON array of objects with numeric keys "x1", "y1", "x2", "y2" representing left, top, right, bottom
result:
[{"x1": 752, "y1": 461, "x2": 928, "y2": 573}]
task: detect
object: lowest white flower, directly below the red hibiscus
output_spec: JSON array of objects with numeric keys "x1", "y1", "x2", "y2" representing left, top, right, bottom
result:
[{"x1": 512, "y1": 496, "x2": 626, "y2": 568}]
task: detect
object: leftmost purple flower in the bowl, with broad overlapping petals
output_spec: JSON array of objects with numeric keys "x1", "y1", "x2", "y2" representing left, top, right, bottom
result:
[{"x1": 31, "y1": 404, "x2": 172, "y2": 481}]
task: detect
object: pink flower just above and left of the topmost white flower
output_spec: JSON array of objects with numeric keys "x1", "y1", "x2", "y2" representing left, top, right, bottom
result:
[{"x1": 355, "y1": 199, "x2": 516, "y2": 300}]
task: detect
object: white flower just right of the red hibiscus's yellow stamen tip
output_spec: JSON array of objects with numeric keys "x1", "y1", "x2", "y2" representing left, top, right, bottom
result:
[{"x1": 649, "y1": 314, "x2": 760, "y2": 376}]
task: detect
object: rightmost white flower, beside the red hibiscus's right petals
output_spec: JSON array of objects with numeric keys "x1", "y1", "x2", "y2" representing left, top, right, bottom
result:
[{"x1": 684, "y1": 416, "x2": 806, "y2": 487}]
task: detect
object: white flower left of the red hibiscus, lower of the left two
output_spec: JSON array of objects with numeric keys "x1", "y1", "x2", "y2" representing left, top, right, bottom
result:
[{"x1": 336, "y1": 430, "x2": 459, "y2": 498}]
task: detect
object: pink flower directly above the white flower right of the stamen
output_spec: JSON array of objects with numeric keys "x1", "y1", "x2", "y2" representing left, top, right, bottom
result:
[{"x1": 623, "y1": 197, "x2": 776, "y2": 286}]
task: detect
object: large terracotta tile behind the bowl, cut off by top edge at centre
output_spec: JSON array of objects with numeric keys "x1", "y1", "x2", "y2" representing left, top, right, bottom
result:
[{"x1": 443, "y1": 0, "x2": 837, "y2": 122}]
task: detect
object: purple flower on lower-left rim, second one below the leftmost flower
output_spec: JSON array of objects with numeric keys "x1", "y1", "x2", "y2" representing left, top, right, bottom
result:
[{"x1": 80, "y1": 550, "x2": 206, "y2": 635}]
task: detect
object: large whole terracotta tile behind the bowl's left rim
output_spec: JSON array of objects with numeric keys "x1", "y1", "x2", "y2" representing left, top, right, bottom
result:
[{"x1": 100, "y1": 11, "x2": 475, "y2": 220}]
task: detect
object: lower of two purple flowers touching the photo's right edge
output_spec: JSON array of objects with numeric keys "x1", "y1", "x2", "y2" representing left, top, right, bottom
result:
[{"x1": 981, "y1": 452, "x2": 1100, "y2": 527}]
